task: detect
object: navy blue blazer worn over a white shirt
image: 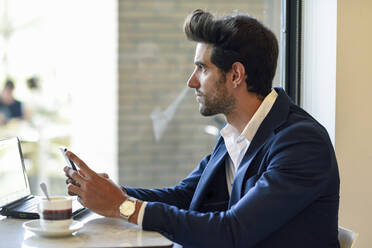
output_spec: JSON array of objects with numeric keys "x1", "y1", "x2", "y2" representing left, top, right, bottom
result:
[{"x1": 125, "y1": 88, "x2": 340, "y2": 248}]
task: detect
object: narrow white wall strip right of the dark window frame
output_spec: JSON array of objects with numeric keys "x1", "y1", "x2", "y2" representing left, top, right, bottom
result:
[{"x1": 301, "y1": 0, "x2": 337, "y2": 144}]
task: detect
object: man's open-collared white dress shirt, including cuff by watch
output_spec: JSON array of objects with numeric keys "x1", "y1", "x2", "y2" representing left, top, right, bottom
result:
[{"x1": 137, "y1": 90, "x2": 278, "y2": 227}]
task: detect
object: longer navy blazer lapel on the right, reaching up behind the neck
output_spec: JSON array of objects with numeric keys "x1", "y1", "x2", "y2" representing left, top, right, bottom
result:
[{"x1": 229, "y1": 88, "x2": 291, "y2": 208}]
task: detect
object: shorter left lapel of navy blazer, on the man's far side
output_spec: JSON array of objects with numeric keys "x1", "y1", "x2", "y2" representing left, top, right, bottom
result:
[{"x1": 189, "y1": 142, "x2": 227, "y2": 210}]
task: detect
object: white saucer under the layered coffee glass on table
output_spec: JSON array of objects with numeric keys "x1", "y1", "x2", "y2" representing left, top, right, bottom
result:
[{"x1": 23, "y1": 220, "x2": 84, "y2": 237}]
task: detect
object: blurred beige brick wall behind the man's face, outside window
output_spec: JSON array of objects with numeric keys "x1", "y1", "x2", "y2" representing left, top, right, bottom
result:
[{"x1": 118, "y1": 0, "x2": 280, "y2": 187}]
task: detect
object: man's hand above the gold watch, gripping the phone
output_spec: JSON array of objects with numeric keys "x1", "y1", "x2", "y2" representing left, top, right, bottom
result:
[{"x1": 63, "y1": 151, "x2": 127, "y2": 217}]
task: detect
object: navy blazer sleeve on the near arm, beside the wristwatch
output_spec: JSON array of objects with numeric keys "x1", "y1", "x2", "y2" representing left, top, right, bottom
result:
[{"x1": 142, "y1": 125, "x2": 333, "y2": 247}]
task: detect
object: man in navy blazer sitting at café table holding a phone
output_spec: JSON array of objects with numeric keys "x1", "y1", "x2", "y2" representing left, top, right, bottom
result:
[{"x1": 65, "y1": 10, "x2": 339, "y2": 248}]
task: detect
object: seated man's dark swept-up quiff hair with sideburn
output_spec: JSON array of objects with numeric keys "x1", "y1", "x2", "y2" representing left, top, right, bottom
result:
[{"x1": 184, "y1": 9, "x2": 278, "y2": 97}]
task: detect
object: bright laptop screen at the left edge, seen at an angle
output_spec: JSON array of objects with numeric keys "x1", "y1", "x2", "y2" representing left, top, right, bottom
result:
[{"x1": 0, "y1": 138, "x2": 31, "y2": 206}]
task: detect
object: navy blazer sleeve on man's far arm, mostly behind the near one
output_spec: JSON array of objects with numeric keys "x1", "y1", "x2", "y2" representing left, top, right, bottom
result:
[{"x1": 122, "y1": 155, "x2": 210, "y2": 209}]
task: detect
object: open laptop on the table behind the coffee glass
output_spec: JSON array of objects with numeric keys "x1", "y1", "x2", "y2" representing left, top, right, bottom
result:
[{"x1": 0, "y1": 137, "x2": 87, "y2": 219}]
